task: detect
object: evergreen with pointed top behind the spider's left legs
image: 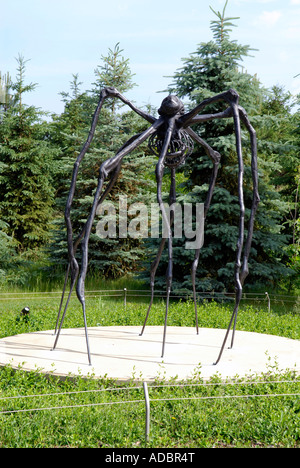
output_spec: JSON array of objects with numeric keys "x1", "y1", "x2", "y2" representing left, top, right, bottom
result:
[{"x1": 51, "y1": 45, "x2": 152, "y2": 278}]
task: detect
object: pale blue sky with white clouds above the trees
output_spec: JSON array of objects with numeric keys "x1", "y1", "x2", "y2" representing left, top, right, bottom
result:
[{"x1": 0, "y1": 0, "x2": 300, "y2": 113}]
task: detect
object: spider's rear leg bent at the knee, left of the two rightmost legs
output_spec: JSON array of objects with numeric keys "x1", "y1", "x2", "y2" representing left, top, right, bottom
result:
[{"x1": 186, "y1": 127, "x2": 221, "y2": 334}]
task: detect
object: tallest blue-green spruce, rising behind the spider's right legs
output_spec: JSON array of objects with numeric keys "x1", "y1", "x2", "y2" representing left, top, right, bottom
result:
[{"x1": 149, "y1": 1, "x2": 288, "y2": 291}]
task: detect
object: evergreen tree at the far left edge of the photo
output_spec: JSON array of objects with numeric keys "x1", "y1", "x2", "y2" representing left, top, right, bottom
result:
[{"x1": 0, "y1": 56, "x2": 54, "y2": 252}]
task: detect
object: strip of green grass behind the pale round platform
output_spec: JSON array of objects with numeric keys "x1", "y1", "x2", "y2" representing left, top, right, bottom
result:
[{"x1": 0, "y1": 290, "x2": 300, "y2": 339}]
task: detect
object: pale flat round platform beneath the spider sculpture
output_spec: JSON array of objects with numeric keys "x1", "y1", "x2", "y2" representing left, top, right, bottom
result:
[{"x1": 0, "y1": 326, "x2": 300, "y2": 382}]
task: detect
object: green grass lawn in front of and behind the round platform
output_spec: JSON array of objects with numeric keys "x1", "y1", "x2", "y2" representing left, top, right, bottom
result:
[{"x1": 0, "y1": 294, "x2": 300, "y2": 448}]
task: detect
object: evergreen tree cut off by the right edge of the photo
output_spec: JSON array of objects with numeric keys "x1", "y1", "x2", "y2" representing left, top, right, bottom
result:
[{"x1": 260, "y1": 85, "x2": 300, "y2": 288}]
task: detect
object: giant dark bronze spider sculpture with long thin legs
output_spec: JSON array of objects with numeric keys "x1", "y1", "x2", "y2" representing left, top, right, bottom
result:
[{"x1": 53, "y1": 87, "x2": 259, "y2": 365}]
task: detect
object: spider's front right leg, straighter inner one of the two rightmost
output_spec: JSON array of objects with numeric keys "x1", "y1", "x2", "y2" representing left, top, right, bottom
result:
[{"x1": 214, "y1": 103, "x2": 245, "y2": 365}]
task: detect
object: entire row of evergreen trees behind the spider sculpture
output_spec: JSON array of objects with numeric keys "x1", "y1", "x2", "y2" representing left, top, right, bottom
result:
[{"x1": 0, "y1": 8, "x2": 300, "y2": 290}]
